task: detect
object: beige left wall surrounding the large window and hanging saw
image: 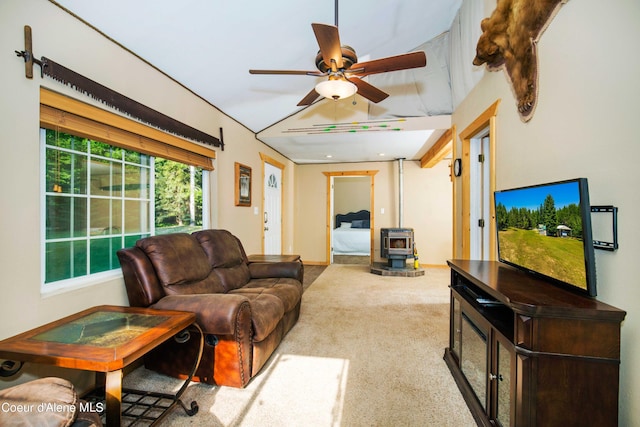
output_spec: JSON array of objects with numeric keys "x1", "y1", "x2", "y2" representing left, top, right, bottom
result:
[{"x1": 0, "y1": 0, "x2": 294, "y2": 388}]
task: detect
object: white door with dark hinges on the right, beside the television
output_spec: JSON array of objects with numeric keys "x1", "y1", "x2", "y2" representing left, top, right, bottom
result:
[{"x1": 469, "y1": 136, "x2": 491, "y2": 260}]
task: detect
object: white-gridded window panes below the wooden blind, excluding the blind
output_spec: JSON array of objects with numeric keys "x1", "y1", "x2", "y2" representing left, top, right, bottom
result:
[{"x1": 42, "y1": 129, "x2": 206, "y2": 290}]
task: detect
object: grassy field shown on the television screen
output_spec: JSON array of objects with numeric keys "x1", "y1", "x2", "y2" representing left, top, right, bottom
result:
[{"x1": 498, "y1": 228, "x2": 587, "y2": 289}]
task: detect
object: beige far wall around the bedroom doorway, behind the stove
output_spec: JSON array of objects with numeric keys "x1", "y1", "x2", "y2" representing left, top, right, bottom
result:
[{"x1": 294, "y1": 160, "x2": 452, "y2": 265}]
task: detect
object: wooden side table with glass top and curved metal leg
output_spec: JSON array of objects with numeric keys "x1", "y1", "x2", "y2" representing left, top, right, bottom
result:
[{"x1": 0, "y1": 305, "x2": 204, "y2": 427}]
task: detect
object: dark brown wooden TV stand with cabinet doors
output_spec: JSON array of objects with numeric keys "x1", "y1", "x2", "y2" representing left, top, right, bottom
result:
[{"x1": 444, "y1": 260, "x2": 626, "y2": 427}]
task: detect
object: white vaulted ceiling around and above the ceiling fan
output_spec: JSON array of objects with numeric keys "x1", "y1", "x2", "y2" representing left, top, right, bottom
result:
[{"x1": 56, "y1": 0, "x2": 462, "y2": 163}]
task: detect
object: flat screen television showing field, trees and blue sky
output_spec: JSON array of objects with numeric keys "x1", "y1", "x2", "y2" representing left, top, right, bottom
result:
[{"x1": 494, "y1": 178, "x2": 596, "y2": 296}]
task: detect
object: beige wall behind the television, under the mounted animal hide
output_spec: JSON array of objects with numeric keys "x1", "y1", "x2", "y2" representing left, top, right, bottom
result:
[{"x1": 453, "y1": 0, "x2": 640, "y2": 426}]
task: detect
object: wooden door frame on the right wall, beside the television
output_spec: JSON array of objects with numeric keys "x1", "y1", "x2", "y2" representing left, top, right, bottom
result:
[{"x1": 454, "y1": 99, "x2": 501, "y2": 261}]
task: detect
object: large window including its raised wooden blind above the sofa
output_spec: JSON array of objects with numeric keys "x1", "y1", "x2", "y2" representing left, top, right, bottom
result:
[{"x1": 40, "y1": 88, "x2": 216, "y2": 292}]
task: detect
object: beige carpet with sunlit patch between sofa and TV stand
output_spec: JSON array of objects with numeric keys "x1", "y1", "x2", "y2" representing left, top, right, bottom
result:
[{"x1": 125, "y1": 264, "x2": 475, "y2": 427}]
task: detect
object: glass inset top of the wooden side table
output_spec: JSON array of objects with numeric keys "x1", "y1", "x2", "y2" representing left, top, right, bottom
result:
[{"x1": 31, "y1": 311, "x2": 169, "y2": 347}]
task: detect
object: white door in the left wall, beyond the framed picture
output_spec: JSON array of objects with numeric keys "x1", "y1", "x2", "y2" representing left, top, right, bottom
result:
[{"x1": 262, "y1": 162, "x2": 282, "y2": 255}]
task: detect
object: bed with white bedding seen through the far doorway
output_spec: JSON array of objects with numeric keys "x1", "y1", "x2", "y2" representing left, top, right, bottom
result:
[{"x1": 332, "y1": 210, "x2": 371, "y2": 256}]
